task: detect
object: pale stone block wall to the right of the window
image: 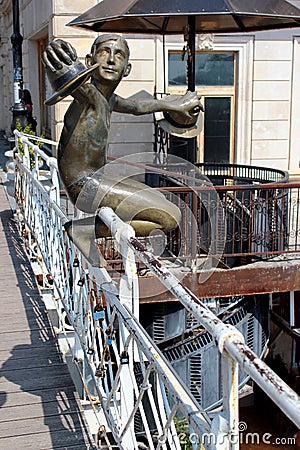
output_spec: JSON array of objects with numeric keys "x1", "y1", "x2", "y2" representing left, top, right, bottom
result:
[{"x1": 251, "y1": 29, "x2": 300, "y2": 178}]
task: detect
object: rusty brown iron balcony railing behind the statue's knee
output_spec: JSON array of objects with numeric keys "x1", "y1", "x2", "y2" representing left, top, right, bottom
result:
[{"x1": 139, "y1": 158, "x2": 294, "y2": 266}]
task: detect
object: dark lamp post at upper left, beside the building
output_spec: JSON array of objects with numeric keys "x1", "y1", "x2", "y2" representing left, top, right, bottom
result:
[{"x1": 10, "y1": 0, "x2": 28, "y2": 131}]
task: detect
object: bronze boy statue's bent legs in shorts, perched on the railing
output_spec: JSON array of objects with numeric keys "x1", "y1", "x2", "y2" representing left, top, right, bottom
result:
[{"x1": 65, "y1": 174, "x2": 181, "y2": 267}]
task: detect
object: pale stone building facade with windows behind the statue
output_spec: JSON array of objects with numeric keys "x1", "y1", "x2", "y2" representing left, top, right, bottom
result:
[{"x1": 0, "y1": 0, "x2": 300, "y2": 178}]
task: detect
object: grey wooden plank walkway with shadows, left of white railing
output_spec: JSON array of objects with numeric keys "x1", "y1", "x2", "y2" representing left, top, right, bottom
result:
[{"x1": 0, "y1": 178, "x2": 96, "y2": 450}]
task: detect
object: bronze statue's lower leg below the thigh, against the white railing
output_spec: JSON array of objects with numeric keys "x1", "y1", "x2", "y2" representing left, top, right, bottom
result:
[{"x1": 64, "y1": 216, "x2": 108, "y2": 267}]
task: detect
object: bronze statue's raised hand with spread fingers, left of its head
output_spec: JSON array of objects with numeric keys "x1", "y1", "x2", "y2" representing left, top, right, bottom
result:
[{"x1": 42, "y1": 39, "x2": 77, "y2": 72}]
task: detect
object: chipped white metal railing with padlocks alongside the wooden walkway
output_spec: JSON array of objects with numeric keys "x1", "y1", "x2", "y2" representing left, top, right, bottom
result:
[{"x1": 10, "y1": 131, "x2": 300, "y2": 450}]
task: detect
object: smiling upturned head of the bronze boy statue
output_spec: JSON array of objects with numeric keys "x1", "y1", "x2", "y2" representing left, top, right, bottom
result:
[{"x1": 86, "y1": 34, "x2": 131, "y2": 84}]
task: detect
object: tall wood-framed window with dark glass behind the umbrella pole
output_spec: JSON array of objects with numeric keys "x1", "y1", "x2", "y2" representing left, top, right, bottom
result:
[{"x1": 168, "y1": 51, "x2": 236, "y2": 163}]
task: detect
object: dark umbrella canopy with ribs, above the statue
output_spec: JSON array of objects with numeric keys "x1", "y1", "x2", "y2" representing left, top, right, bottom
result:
[{"x1": 68, "y1": 0, "x2": 300, "y2": 34}]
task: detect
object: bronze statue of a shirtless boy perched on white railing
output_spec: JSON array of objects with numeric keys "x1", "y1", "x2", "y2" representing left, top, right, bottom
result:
[{"x1": 42, "y1": 34, "x2": 202, "y2": 266}]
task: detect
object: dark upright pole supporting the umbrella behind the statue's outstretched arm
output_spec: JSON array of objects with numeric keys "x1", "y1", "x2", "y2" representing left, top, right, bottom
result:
[{"x1": 187, "y1": 16, "x2": 197, "y2": 164}]
